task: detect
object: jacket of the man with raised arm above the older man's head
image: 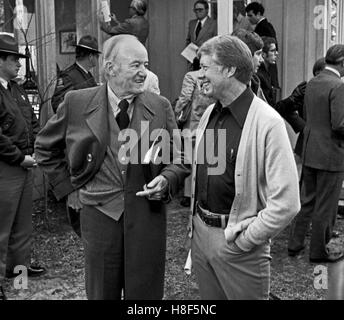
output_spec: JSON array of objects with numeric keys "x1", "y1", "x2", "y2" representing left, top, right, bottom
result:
[{"x1": 101, "y1": 16, "x2": 149, "y2": 45}]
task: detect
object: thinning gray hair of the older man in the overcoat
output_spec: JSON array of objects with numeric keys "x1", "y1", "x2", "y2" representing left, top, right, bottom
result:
[{"x1": 102, "y1": 34, "x2": 139, "y2": 80}]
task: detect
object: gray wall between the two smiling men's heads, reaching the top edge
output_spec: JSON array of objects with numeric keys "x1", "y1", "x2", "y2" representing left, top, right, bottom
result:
[{"x1": 148, "y1": 0, "x2": 195, "y2": 101}]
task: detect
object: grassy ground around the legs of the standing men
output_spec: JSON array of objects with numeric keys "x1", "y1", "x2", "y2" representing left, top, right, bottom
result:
[{"x1": 5, "y1": 194, "x2": 344, "y2": 300}]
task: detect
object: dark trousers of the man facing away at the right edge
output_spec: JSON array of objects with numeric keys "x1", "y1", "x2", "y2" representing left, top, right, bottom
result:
[{"x1": 288, "y1": 166, "x2": 344, "y2": 259}]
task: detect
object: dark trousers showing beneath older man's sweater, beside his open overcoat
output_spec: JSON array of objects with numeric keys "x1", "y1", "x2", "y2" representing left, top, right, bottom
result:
[{"x1": 80, "y1": 206, "x2": 124, "y2": 300}]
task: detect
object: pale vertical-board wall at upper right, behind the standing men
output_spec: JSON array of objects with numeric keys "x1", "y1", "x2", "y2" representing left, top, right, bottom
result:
[{"x1": 261, "y1": 0, "x2": 324, "y2": 97}]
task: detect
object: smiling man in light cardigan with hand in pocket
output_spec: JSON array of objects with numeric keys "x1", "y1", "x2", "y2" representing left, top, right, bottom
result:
[{"x1": 190, "y1": 35, "x2": 300, "y2": 300}]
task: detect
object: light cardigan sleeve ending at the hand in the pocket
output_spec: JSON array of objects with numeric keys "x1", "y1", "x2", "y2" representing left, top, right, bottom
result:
[{"x1": 235, "y1": 119, "x2": 301, "y2": 252}]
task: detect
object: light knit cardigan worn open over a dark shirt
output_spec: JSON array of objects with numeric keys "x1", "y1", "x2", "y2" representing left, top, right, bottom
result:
[{"x1": 190, "y1": 96, "x2": 300, "y2": 252}]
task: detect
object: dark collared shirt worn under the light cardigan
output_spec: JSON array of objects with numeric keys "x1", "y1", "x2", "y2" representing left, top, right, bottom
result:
[{"x1": 196, "y1": 88, "x2": 254, "y2": 214}]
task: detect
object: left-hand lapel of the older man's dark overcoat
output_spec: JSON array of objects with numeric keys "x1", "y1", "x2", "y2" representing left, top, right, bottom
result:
[{"x1": 84, "y1": 84, "x2": 109, "y2": 144}]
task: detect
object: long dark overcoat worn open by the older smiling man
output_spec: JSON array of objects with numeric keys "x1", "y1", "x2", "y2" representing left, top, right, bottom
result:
[{"x1": 35, "y1": 85, "x2": 189, "y2": 300}]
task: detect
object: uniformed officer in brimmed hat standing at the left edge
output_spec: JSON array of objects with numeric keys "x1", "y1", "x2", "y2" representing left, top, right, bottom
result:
[{"x1": 0, "y1": 34, "x2": 45, "y2": 300}]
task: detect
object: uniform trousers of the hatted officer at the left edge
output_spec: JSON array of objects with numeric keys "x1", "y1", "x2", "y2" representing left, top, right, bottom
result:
[{"x1": 0, "y1": 161, "x2": 33, "y2": 283}]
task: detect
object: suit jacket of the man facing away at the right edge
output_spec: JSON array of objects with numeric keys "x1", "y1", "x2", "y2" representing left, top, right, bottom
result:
[{"x1": 303, "y1": 69, "x2": 344, "y2": 172}]
